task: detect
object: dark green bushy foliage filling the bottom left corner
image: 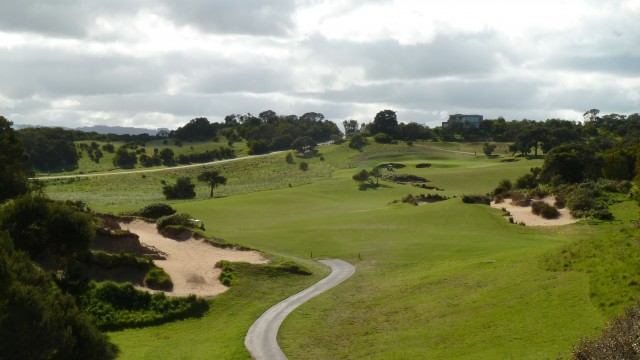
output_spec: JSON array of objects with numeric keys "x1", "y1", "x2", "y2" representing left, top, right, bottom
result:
[{"x1": 0, "y1": 232, "x2": 117, "y2": 359}]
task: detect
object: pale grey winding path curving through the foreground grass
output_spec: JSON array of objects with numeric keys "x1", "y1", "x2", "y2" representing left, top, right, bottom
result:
[{"x1": 244, "y1": 259, "x2": 356, "y2": 360}]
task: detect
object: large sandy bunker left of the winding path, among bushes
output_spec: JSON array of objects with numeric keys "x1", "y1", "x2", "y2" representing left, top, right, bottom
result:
[{"x1": 120, "y1": 220, "x2": 268, "y2": 297}]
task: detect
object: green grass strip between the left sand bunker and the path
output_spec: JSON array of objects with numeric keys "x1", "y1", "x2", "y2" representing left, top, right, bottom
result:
[{"x1": 109, "y1": 263, "x2": 327, "y2": 359}]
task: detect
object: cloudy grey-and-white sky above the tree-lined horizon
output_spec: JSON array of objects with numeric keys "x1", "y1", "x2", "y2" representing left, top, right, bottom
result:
[{"x1": 0, "y1": 0, "x2": 640, "y2": 129}]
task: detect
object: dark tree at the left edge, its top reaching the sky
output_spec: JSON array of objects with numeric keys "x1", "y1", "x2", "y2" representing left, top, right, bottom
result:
[{"x1": 0, "y1": 116, "x2": 28, "y2": 203}]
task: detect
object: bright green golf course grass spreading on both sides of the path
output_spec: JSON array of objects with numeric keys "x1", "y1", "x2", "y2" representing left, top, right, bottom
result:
[{"x1": 40, "y1": 143, "x2": 637, "y2": 359}]
